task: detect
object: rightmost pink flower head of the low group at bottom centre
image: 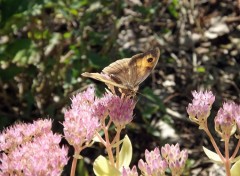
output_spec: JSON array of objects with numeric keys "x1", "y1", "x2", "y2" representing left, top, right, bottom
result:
[{"x1": 161, "y1": 144, "x2": 188, "y2": 175}]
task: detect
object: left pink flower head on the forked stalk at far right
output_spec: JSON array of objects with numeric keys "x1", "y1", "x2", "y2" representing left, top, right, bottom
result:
[{"x1": 187, "y1": 91, "x2": 215, "y2": 127}]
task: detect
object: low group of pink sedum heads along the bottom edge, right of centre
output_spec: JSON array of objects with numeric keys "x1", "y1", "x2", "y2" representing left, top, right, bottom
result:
[{"x1": 122, "y1": 144, "x2": 188, "y2": 176}]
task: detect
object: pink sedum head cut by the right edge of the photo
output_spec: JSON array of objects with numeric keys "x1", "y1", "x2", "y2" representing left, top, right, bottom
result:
[{"x1": 214, "y1": 102, "x2": 238, "y2": 140}]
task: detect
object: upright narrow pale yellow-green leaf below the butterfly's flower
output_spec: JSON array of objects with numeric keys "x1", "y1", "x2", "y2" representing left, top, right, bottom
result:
[{"x1": 119, "y1": 135, "x2": 132, "y2": 167}]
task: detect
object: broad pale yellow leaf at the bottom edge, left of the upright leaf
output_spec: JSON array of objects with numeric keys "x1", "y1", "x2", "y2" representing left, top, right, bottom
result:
[{"x1": 93, "y1": 155, "x2": 121, "y2": 176}]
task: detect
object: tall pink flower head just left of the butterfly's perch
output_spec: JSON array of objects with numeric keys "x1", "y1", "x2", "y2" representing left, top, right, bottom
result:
[{"x1": 63, "y1": 87, "x2": 100, "y2": 150}]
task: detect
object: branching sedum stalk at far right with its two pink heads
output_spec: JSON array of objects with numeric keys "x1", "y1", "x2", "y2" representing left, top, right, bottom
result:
[{"x1": 187, "y1": 91, "x2": 240, "y2": 176}]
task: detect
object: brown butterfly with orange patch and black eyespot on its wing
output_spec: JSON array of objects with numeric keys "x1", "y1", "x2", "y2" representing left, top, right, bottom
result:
[{"x1": 82, "y1": 48, "x2": 160, "y2": 97}]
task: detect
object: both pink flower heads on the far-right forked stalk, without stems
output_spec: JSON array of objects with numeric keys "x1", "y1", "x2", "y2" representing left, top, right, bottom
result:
[{"x1": 187, "y1": 91, "x2": 240, "y2": 140}]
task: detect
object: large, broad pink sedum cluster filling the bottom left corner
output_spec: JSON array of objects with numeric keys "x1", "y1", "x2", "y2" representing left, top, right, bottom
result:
[{"x1": 0, "y1": 120, "x2": 68, "y2": 176}]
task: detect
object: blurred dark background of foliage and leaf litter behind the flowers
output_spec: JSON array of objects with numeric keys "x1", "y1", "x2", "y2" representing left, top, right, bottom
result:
[{"x1": 0, "y1": 0, "x2": 240, "y2": 176}]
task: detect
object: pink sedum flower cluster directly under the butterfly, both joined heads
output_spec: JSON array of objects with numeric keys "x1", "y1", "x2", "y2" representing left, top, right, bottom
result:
[{"x1": 63, "y1": 87, "x2": 135, "y2": 149}]
